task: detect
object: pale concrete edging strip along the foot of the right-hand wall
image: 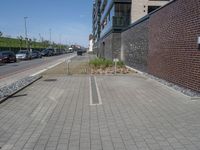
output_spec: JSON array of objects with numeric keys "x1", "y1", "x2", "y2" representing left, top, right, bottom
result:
[{"x1": 126, "y1": 66, "x2": 200, "y2": 101}]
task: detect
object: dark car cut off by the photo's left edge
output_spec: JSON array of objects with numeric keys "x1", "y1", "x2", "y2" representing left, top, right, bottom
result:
[{"x1": 0, "y1": 51, "x2": 17, "y2": 63}]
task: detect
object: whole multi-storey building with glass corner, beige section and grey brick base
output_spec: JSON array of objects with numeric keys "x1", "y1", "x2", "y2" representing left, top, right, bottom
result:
[{"x1": 93, "y1": 0, "x2": 170, "y2": 59}]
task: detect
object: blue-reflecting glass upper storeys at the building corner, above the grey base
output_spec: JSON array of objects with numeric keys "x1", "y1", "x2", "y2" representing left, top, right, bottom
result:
[{"x1": 100, "y1": 0, "x2": 131, "y2": 37}]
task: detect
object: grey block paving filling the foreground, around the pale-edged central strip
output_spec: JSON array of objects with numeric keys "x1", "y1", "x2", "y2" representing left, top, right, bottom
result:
[{"x1": 0, "y1": 75, "x2": 200, "y2": 150}]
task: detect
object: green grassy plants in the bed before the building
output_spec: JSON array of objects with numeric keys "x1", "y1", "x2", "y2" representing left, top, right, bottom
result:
[{"x1": 89, "y1": 58, "x2": 125, "y2": 69}]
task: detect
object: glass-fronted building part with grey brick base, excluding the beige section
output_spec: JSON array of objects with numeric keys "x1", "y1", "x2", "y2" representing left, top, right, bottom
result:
[{"x1": 95, "y1": 0, "x2": 131, "y2": 59}]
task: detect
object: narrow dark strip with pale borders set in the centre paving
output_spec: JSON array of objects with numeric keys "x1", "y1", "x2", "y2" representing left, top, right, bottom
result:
[{"x1": 89, "y1": 76, "x2": 102, "y2": 106}]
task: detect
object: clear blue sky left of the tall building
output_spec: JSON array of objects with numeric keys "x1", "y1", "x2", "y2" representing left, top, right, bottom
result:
[{"x1": 0, "y1": 0, "x2": 92, "y2": 46}]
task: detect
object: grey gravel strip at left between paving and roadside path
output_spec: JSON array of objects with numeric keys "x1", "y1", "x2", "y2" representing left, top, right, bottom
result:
[{"x1": 0, "y1": 76, "x2": 41, "y2": 101}]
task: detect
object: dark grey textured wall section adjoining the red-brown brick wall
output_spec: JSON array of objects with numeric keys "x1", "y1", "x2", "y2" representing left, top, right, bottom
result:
[{"x1": 121, "y1": 19, "x2": 149, "y2": 72}]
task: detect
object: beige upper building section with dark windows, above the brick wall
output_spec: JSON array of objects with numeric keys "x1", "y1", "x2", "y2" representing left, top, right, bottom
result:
[{"x1": 131, "y1": 0, "x2": 171, "y2": 23}]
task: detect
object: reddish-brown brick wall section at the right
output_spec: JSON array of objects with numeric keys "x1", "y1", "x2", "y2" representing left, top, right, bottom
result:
[{"x1": 148, "y1": 0, "x2": 200, "y2": 91}]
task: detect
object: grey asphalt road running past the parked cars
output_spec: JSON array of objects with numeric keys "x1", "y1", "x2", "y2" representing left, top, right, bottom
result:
[{"x1": 0, "y1": 54, "x2": 71, "y2": 79}]
